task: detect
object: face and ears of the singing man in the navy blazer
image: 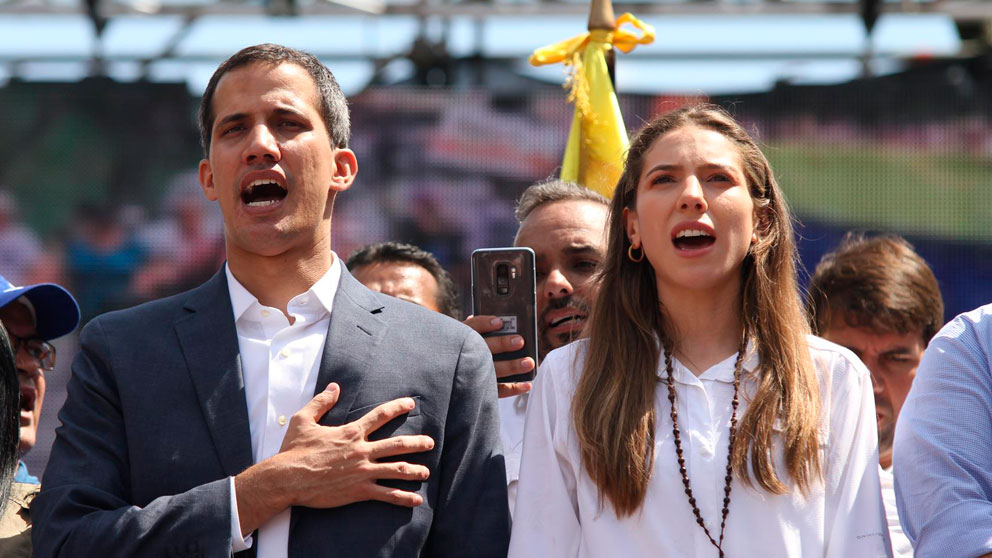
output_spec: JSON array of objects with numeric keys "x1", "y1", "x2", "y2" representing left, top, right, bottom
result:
[{"x1": 200, "y1": 63, "x2": 358, "y2": 264}]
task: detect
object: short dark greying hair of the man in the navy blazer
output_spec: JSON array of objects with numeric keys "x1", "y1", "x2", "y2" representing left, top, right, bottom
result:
[{"x1": 199, "y1": 43, "x2": 351, "y2": 157}]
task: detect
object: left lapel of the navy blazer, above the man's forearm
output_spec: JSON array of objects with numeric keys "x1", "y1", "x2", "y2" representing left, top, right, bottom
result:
[{"x1": 175, "y1": 268, "x2": 254, "y2": 476}]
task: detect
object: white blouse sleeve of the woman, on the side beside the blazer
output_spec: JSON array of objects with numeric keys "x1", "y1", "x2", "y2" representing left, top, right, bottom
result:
[{"x1": 509, "y1": 350, "x2": 581, "y2": 558}]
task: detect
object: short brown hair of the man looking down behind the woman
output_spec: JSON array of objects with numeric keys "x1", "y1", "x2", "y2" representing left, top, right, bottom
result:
[{"x1": 807, "y1": 233, "x2": 944, "y2": 346}]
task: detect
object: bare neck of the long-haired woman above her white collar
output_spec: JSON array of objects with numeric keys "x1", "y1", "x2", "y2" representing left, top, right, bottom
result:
[{"x1": 659, "y1": 289, "x2": 743, "y2": 376}]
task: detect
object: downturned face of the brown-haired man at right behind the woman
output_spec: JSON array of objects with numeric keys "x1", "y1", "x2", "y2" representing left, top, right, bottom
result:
[{"x1": 821, "y1": 310, "x2": 926, "y2": 468}]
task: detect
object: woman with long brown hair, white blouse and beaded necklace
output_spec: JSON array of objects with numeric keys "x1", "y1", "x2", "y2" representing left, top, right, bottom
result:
[{"x1": 510, "y1": 105, "x2": 891, "y2": 558}]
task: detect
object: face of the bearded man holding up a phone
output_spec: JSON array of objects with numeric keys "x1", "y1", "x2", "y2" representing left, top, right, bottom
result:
[{"x1": 514, "y1": 200, "x2": 609, "y2": 358}]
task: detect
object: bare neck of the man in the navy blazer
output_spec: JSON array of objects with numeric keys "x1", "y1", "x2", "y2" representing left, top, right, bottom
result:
[{"x1": 227, "y1": 248, "x2": 334, "y2": 322}]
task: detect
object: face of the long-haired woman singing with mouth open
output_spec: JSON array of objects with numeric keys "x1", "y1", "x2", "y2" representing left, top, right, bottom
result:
[{"x1": 626, "y1": 126, "x2": 757, "y2": 301}]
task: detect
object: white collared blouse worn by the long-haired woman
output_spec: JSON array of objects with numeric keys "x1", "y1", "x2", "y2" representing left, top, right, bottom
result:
[{"x1": 509, "y1": 336, "x2": 892, "y2": 558}]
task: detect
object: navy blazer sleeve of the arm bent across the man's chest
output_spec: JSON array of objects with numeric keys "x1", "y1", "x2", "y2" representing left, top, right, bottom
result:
[{"x1": 31, "y1": 319, "x2": 231, "y2": 558}]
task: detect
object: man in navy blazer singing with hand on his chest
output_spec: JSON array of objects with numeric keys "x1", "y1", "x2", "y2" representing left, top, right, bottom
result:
[{"x1": 32, "y1": 45, "x2": 509, "y2": 557}]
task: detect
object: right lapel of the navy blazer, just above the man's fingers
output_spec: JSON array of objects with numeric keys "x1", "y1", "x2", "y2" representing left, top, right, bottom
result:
[{"x1": 314, "y1": 266, "x2": 388, "y2": 426}]
